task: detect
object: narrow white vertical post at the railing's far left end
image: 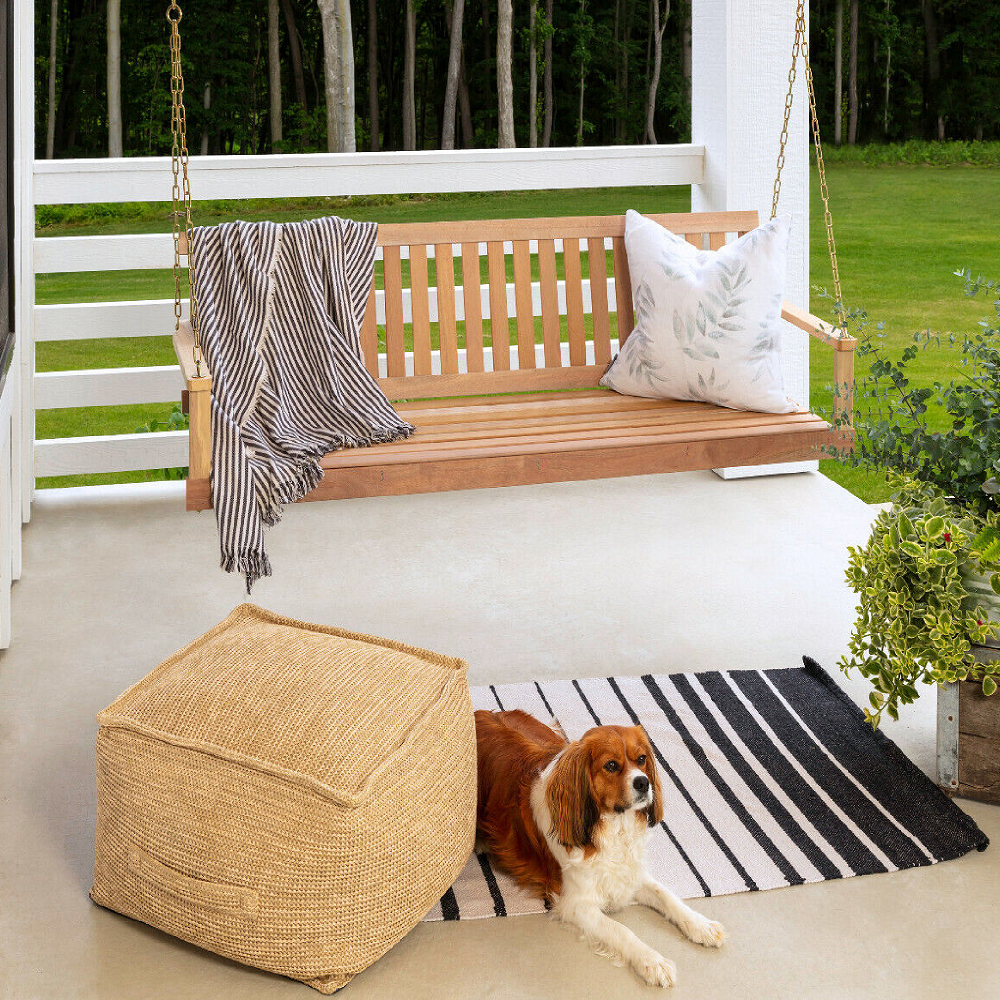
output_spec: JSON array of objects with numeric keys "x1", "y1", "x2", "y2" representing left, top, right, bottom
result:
[{"x1": 12, "y1": 0, "x2": 35, "y2": 523}]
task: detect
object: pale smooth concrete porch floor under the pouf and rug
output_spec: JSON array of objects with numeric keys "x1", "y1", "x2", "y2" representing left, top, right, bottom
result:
[{"x1": 0, "y1": 473, "x2": 1000, "y2": 1000}]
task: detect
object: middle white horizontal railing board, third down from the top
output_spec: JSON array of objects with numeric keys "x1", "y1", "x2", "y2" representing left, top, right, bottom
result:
[{"x1": 35, "y1": 278, "x2": 615, "y2": 341}]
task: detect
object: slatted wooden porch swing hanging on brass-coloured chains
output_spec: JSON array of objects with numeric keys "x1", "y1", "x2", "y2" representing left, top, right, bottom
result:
[{"x1": 167, "y1": 0, "x2": 856, "y2": 510}]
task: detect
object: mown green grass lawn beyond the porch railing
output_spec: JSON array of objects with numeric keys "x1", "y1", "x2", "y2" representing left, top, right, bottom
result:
[{"x1": 36, "y1": 163, "x2": 1000, "y2": 502}]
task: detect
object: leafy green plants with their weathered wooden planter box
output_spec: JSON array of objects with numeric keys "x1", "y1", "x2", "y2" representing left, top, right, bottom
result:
[{"x1": 840, "y1": 272, "x2": 1000, "y2": 801}]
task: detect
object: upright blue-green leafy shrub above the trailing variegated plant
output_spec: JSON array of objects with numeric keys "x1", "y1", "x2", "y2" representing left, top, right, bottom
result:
[{"x1": 845, "y1": 270, "x2": 1000, "y2": 513}]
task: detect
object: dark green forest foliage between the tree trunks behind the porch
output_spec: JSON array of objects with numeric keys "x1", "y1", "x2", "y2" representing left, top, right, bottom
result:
[{"x1": 35, "y1": 0, "x2": 1000, "y2": 163}]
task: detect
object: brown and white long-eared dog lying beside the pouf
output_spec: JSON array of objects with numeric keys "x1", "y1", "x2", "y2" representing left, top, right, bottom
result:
[{"x1": 476, "y1": 710, "x2": 725, "y2": 986}]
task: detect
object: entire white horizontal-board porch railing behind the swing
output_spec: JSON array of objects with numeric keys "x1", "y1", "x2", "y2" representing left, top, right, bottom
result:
[{"x1": 31, "y1": 145, "x2": 705, "y2": 476}]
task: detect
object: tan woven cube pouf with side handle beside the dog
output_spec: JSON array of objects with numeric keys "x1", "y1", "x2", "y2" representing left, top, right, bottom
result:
[{"x1": 91, "y1": 604, "x2": 476, "y2": 993}]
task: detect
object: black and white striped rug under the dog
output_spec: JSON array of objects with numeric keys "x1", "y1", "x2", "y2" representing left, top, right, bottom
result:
[{"x1": 424, "y1": 658, "x2": 989, "y2": 920}]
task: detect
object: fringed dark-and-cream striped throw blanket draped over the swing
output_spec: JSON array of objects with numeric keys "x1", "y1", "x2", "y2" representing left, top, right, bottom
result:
[{"x1": 192, "y1": 218, "x2": 413, "y2": 593}]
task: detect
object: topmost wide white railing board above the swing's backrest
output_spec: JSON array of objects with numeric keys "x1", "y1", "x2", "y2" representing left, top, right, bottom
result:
[{"x1": 34, "y1": 144, "x2": 705, "y2": 205}]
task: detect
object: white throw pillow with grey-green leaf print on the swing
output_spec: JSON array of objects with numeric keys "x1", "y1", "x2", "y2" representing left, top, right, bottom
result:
[{"x1": 601, "y1": 210, "x2": 800, "y2": 413}]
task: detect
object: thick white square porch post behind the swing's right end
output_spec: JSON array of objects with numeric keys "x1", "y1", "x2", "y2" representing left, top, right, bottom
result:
[{"x1": 691, "y1": 0, "x2": 817, "y2": 479}]
